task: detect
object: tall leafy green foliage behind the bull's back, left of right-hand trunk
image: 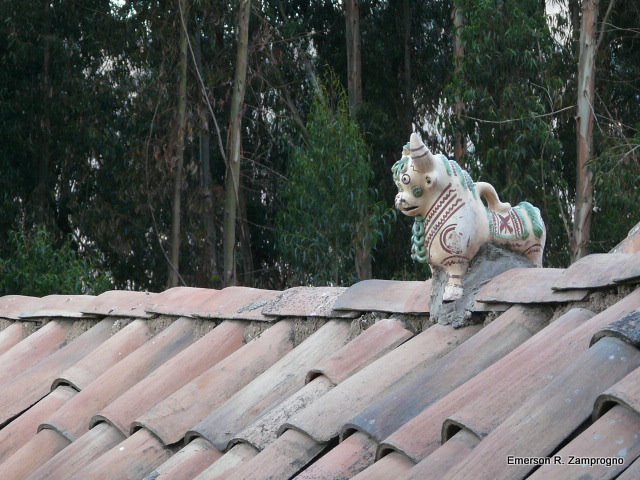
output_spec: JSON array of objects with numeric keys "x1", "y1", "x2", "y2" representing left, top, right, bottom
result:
[{"x1": 445, "y1": 0, "x2": 575, "y2": 266}]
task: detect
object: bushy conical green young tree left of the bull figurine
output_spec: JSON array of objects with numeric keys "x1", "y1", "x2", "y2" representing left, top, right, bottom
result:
[{"x1": 277, "y1": 83, "x2": 383, "y2": 285}]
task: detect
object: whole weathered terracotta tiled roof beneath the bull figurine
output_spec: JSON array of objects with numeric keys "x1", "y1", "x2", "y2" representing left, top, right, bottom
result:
[{"x1": 0, "y1": 223, "x2": 640, "y2": 480}]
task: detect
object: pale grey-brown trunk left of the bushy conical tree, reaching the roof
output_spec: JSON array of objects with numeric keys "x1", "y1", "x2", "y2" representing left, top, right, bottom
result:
[{"x1": 223, "y1": 0, "x2": 251, "y2": 286}]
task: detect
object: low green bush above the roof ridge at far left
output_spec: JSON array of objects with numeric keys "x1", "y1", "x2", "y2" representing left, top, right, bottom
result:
[{"x1": 0, "y1": 228, "x2": 111, "y2": 297}]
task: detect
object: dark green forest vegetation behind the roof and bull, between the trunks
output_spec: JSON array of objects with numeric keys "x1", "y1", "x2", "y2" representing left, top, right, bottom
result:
[{"x1": 0, "y1": 0, "x2": 640, "y2": 295}]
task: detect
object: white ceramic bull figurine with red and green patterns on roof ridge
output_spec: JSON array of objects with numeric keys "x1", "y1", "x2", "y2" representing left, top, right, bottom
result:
[{"x1": 392, "y1": 133, "x2": 546, "y2": 301}]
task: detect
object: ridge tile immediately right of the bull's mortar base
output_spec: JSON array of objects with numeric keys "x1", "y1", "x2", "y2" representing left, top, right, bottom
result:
[{"x1": 476, "y1": 268, "x2": 589, "y2": 303}]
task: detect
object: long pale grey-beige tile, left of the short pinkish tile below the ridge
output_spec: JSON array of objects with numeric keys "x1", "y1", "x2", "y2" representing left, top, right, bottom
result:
[{"x1": 188, "y1": 320, "x2": 349, "y2": 451}]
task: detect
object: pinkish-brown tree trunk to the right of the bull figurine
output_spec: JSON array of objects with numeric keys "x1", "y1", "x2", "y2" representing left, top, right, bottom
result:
[{"x1": 571, "y1": 0, "x2": 599, "y2": 261}]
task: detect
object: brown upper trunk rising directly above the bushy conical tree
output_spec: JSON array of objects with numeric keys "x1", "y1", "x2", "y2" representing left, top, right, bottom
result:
[{"x1": 344, "y1": 0, "x2": 362, "y2": 115}]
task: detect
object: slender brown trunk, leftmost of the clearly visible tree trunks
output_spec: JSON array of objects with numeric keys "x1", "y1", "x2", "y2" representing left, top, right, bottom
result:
[{"x1": 167, "y1": 0, "x2": 188, "y2": 288}]
